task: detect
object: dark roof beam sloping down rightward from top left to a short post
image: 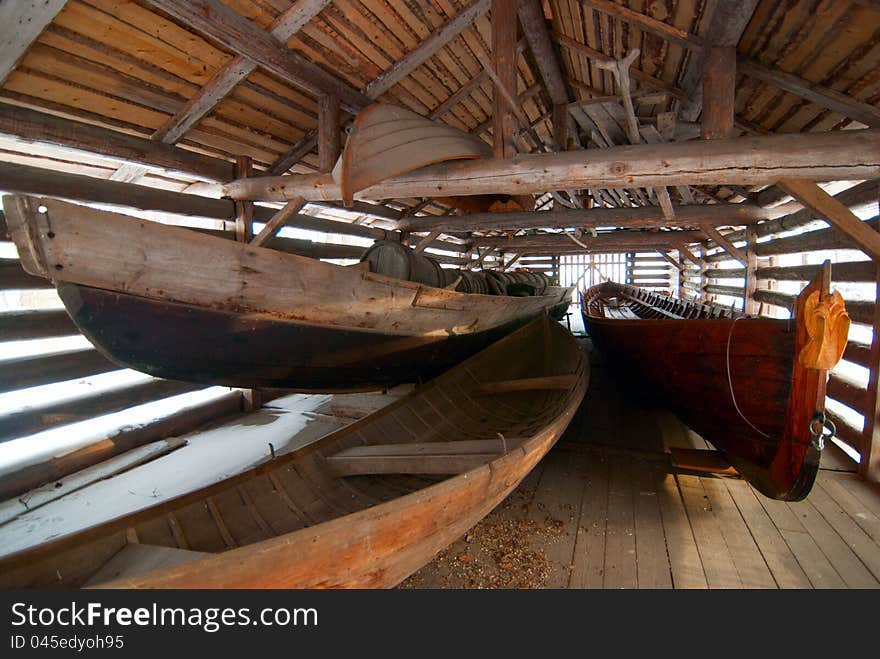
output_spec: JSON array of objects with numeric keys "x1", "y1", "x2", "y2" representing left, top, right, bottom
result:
[{"x1": 147, "y1": 0, "x2": 372, "y2": 113}]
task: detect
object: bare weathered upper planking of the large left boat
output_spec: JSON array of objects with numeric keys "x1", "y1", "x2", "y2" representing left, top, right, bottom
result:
[{"x1": 4, "y1": 196, "x2": 570, "y2": 337}]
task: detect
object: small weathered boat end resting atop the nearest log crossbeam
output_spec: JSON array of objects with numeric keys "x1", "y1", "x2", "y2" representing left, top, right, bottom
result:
[{"x1": 334, "y1": 103, "x2": 492, "y2": 204}]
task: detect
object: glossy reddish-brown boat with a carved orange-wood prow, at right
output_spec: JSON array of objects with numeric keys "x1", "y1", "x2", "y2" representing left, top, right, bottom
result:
[{"x1": 582, "y1": 263, "x2": 849, "y2": 501}]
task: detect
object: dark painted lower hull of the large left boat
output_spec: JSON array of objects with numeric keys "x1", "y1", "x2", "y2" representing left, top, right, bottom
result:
[{"x1": 58, "y1": 284, "x2": 544, "y2": 392}]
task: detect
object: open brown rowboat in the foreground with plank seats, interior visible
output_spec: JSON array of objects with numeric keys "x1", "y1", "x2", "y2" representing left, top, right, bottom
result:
[{"x1": 0, "y1": 316, "x2": 589, "y2": 588}]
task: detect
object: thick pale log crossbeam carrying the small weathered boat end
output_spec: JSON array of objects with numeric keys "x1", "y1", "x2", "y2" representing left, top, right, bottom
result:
[{"x1": 222, "y1": 129, "x2": 880, "y2": 201}]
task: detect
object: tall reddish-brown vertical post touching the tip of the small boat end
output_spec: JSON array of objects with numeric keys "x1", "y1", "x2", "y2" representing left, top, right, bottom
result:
[{"x1": 491, "y1": 0, "x2": 517, "y2": 158}]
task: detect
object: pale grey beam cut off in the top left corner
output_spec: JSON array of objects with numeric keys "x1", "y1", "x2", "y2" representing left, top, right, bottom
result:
[{"x1": 0, "y1": 0, "x2": 67, "y2": 85}]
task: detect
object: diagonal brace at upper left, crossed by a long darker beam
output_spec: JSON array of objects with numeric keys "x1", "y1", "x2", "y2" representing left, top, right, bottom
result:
[{"x1": 153, "y1": 0, "x2": 330, "y2": 144}]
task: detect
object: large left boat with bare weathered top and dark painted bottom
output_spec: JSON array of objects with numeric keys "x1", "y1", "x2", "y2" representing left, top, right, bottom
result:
[{"x1": 4, "y1": 196, "x2": 571, "y2": 392}]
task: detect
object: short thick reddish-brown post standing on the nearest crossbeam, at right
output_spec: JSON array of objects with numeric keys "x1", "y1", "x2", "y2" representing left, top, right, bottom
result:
[{"x1": 700, "y1": 46, "x2": 736, "y2": 140}]
